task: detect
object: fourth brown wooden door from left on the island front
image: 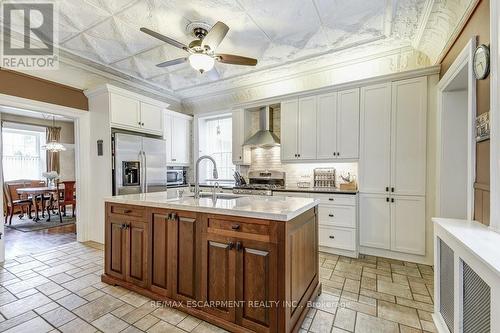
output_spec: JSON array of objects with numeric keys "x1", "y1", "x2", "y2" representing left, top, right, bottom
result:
[{"x1": 172, "y1": 213, "x2": 201, "y2": 300}]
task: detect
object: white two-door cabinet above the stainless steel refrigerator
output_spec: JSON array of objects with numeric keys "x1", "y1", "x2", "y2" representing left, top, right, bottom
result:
[{"x1": 85, "y1": 84, "x2": 168, "y2": 136}]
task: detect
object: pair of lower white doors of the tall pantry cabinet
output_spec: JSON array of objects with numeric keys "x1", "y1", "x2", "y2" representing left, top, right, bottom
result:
[{"x1": 359, "y1": 193, "x2": 425, "y2": 255}]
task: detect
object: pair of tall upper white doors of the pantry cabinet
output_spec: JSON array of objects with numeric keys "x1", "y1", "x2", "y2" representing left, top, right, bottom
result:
[{"x1": 359, "y1": 77, "x2": 427, "y2": 195}]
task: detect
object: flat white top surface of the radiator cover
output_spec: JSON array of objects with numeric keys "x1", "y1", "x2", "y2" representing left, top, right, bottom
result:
[{"x1": 432, "y1": 218, "x2": 500, "y2": 276}]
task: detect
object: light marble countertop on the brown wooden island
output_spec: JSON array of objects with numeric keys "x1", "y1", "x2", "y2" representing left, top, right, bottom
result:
[{"x1": 105, "y1": 191, "x2": 319, "y2": 221}]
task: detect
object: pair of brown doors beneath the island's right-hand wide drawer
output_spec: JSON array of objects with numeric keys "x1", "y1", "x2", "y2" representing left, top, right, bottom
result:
[{"x1": 202, "y1": 233, "x2": 277, "y2": 332}]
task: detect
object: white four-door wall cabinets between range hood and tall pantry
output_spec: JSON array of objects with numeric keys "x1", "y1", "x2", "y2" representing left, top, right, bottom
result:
[{"x1": 281, "y1": 89, "x2": 359, "y2": 161}]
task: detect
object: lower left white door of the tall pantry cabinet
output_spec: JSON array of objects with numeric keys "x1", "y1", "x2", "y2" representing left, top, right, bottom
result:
[{"x1": 359, "y1": 194, "x2": 391, "y2": 249}]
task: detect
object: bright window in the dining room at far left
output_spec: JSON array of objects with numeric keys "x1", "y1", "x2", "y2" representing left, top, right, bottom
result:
[{"x1": 2, "y1": 123, "x2": 46, "y2": 181}]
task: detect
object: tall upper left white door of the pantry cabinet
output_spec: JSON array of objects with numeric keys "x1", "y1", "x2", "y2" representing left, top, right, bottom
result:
[{"x1": 359, "y1": 83, "x2": 391, "y2": 193}]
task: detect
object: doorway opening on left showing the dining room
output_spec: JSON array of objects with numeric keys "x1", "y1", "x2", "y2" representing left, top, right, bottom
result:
[{"x1": 0, "y1": 107, "x2": 77, "y2": 259}]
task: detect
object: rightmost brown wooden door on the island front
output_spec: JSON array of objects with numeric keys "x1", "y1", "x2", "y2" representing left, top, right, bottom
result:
[{"x1": 235, "y1": 240, "x2": 278, "y2": 332}]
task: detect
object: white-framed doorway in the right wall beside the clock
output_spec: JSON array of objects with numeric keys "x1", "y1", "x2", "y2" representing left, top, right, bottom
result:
[{"x1": 437, "y1": 39, "x2": 476, "y2": 220}]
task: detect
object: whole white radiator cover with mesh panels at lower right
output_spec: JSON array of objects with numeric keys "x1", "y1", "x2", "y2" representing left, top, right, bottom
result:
[{"x1": 433, "y1": 218, "x2": 500, "y2": 333}]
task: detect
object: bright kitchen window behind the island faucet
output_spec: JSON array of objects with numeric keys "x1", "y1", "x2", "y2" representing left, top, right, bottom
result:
[{"x1": 199, "y1": 114, "x2": 234, "y2": 181}]
